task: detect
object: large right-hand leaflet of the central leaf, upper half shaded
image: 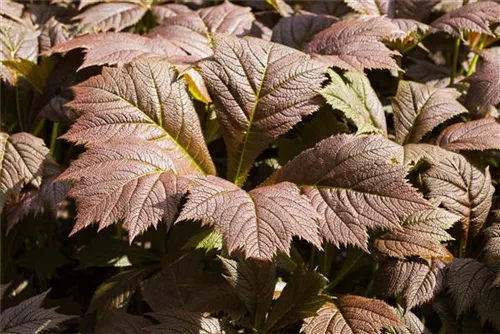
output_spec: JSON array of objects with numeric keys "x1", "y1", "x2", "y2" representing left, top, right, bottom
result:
[{"x1": 266, "y1": 135, "x2": 431, "y2": 251}]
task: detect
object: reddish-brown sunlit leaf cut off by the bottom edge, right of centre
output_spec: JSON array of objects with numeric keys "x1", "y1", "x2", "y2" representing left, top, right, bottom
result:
[{"x1": 302, "y1": 295, "x2": 402, "y2": 334}]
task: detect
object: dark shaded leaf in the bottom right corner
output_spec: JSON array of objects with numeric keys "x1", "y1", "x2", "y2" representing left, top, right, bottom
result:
[{"x1": 446, "y1": 259, "x2": 500, "y2": 330}]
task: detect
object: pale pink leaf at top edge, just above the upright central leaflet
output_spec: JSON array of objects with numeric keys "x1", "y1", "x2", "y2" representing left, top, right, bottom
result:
[{"x1": 148, "y1": 1, "x2": 255, "y2": 58}]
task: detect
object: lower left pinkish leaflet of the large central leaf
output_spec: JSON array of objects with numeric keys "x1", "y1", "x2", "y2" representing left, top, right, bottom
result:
[{"x1": 59, "y1": 138, "x2": 188, "y2": 240}]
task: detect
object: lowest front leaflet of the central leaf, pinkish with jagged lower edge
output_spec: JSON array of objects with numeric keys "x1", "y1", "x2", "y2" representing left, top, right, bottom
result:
[{"x1": 177, "y1": 176, "x2": 321, "y2": 261}]
